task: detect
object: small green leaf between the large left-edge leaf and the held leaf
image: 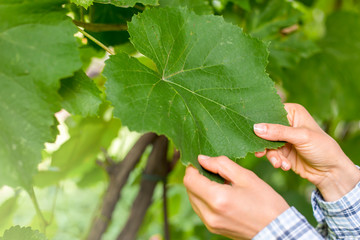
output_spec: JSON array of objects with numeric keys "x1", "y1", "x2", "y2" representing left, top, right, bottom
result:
[{"x1": 59, "y1": 71, "x2": 102, "y2": 117}]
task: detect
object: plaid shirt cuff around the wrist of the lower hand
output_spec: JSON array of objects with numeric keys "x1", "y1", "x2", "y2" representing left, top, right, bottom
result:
[{"x1": 253, "y1": 207, "x2": 324, "y2": 240}]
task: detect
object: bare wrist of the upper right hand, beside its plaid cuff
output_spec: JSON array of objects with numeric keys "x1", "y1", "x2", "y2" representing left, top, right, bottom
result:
[{"x1": 316, "y1": 158, "x2": 360, "y2": 202}]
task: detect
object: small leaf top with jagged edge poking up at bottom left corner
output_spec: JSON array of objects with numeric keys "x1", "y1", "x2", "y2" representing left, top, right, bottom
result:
[{"x1": 0, "y1": 226, "x2": 47, "y2": 240}]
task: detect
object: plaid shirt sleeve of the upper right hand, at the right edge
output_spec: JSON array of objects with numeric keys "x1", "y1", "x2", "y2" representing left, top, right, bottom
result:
[{"x1": 311, "y1": 183, "x2": 360, "y2": 239}]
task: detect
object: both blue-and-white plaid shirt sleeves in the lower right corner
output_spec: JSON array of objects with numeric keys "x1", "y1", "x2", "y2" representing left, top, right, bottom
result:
[{"x1": 253, "y1": 183, "x2": 360, "y2": 240}]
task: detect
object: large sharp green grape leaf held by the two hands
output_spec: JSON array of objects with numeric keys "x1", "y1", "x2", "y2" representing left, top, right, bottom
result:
[{"x1": 104, "y1": 8, "x2": 287, "y2": 179}]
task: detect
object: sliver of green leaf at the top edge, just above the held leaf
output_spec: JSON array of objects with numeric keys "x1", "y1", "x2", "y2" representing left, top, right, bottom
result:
[{"x1": 159, "y1": 0, "x2": 214, "y2": 14}]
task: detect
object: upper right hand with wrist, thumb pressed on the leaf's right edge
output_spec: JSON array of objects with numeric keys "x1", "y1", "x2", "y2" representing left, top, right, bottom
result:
[{"x1": 254, "y1": 103, "x2": 360, "y2": 201}]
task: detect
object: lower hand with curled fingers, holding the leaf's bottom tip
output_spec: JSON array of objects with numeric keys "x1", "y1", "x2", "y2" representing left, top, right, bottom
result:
[{"x1": 184, "y1": 155, "x2": 289, "y2": 239}]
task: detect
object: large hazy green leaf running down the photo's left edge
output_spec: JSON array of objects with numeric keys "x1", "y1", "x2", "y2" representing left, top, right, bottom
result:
[{"x1": 0, "y1": 0, "x2": 81, "y2": 187}]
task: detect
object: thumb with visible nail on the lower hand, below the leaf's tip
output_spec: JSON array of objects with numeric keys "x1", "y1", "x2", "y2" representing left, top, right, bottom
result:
[{"x1": 198, "y1": 155, "x2": 245, "y2": 183}]
